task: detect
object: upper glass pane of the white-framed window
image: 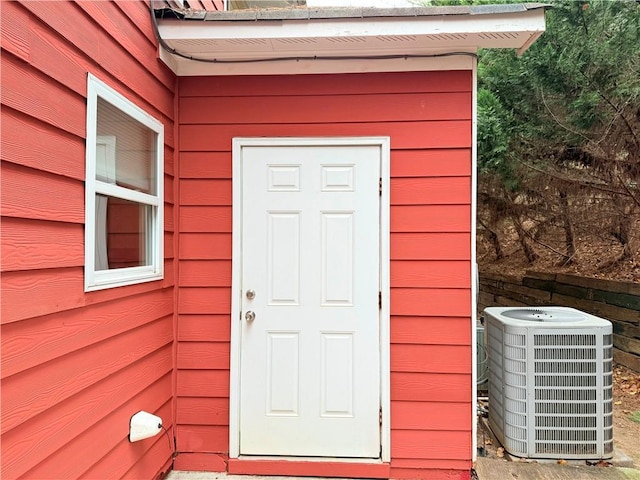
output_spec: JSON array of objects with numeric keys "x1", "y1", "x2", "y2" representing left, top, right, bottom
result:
[{"x1": 96, "y1": 97, "x2": 157, "y2": 195}]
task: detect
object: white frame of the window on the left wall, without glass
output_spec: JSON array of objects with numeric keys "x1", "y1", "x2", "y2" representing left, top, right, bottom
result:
[{"x1": 84, "y1": 74, "x2": 164, "y2": 292}]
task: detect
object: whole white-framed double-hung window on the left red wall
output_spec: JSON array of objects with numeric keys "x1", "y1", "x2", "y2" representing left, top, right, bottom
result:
[{"x1": 85, "y1": 75, "x2": 164, "y2": 291}]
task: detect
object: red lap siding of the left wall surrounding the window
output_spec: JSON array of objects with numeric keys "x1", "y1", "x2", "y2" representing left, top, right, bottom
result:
[{"x1": 0, "y1": 1, "x2": 177, "y2": 479}]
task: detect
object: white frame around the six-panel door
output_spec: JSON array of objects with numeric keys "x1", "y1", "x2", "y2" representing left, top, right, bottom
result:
[{"x1": 229, "y1": 137, "x2": 391, "y2": 462}]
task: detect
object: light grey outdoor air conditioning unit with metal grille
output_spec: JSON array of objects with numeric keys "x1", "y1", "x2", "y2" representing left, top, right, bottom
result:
[{"x1": 484, "y1": 307, "x2": 613, "y2": 459}]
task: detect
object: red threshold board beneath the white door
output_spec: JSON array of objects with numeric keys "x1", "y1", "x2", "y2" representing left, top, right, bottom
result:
[{"x1": 228, "y1": 455, "x2": 391, "y2": 478}]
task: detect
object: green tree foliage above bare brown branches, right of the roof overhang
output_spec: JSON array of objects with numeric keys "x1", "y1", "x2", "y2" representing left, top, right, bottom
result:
[{"x1": 476, "y1": 0, "x2": 640, "y2": 177}]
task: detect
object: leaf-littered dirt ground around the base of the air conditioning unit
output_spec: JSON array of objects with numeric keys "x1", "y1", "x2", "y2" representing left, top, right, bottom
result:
[{"x1": 477, "y1": 365, "x2": 640, "y2": 470}]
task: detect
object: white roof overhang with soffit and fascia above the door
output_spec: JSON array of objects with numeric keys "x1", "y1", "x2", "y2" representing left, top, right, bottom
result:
[{"x1": 158, "y1": 4, "x2": 545, "y2": 76}]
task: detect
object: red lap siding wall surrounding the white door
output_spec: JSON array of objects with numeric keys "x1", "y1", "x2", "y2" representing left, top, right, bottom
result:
[{"x1": 177, "y1": 71, "x2": 472, "y2": 478}]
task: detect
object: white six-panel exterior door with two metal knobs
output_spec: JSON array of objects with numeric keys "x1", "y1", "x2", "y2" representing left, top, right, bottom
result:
[{"x1": 238, "y1": 141, "x2": 381, "y2": 458}]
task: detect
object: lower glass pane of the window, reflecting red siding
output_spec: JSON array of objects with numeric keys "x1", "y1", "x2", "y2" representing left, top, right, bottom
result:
[{"x1": 95, "y1": 195, "x2": 153, "y2": 270}]
